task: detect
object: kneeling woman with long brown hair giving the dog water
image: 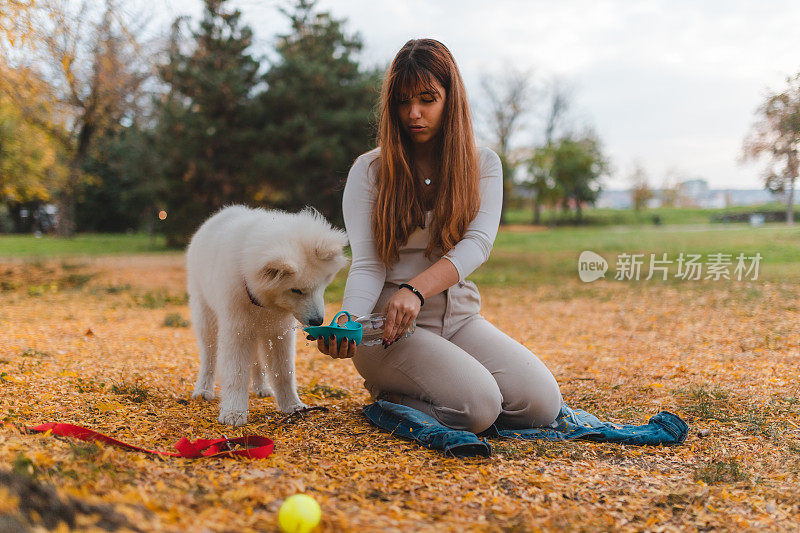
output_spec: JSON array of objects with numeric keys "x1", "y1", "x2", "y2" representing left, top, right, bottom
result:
[{"x1": 306, "y1": 39, "x2": 562, "y2": 433}]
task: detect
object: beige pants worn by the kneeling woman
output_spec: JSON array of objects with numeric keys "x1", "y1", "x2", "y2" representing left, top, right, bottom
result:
[{"x1": 353, "y1": 281, "x2": 562, "y2": 433}]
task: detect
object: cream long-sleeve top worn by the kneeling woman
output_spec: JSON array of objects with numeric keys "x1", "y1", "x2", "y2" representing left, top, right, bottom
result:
[{"x1": 342, "y1": 147, "x2": 503, "y2": 316}]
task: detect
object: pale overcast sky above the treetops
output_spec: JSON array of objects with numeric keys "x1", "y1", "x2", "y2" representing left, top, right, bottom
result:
[{"x1": 159, "y1": 0, "x2": 800, "y2": 189}]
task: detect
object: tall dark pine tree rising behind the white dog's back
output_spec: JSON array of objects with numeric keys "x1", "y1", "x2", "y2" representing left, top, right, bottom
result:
[{"x1": 154, "y1": 0, "x2": 261, "y2": 246}]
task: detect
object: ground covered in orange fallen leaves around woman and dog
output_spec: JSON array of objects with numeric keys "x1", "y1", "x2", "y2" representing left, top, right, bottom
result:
[{"x1": 0, "y1": 254, "x2": 800, "y2": 531}]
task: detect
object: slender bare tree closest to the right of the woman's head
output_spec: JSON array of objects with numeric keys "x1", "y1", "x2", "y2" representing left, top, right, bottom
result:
[{"x1": 481, "y1": 62, "x2": 533, "y2": 224}]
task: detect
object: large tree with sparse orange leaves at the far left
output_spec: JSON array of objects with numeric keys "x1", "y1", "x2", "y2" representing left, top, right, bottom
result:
[{"x1": 0, "y1": 0, "x2": 154, "y2": 236}]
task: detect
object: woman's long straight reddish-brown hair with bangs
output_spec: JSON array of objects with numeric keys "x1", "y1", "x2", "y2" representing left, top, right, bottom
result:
[{"x1": 372, "y1": 39, "x2": 480, "y2": 267}]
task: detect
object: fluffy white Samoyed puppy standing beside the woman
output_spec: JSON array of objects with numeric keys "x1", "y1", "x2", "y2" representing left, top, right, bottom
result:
[{"x1": 186, "y1": 205, "x2": 349, "y2": 426}]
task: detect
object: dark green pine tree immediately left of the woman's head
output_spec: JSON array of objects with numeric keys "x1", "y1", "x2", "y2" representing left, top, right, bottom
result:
[{"x1": 256, "y1": 0, "x2": 381, "y2": 225}]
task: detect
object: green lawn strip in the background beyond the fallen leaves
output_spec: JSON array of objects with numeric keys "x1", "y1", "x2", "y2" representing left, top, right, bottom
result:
[{"x1": 0, "y1": 223, "x2": 800, "y2": 300}]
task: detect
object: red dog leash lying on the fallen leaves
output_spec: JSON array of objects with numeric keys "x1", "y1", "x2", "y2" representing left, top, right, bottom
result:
[{"x1": 25, "y1": 422, "x2": 274, "y2": 459}]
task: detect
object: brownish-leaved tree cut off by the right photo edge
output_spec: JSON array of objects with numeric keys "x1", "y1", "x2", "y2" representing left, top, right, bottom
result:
[{"x1": 742, "y1": 73, "x2": 800, "y2": 225}]
